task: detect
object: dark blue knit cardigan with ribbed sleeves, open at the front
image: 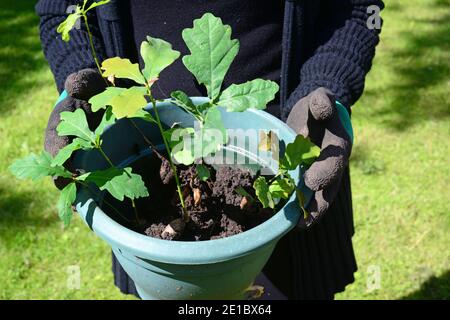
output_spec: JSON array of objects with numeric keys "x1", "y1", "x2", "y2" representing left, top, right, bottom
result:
[{"x1": 36, "y1": 0, "x2": 384, "y2": 117}]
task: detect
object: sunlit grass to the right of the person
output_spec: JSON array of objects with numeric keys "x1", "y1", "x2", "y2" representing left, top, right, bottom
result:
[{"x1": 338, "y1": 1, "x2": 450, "y2": 299}]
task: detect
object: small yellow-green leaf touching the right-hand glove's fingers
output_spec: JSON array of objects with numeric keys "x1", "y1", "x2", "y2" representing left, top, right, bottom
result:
[{"x1": 280, "y1": 135, "x2": 320, "y2": 170}]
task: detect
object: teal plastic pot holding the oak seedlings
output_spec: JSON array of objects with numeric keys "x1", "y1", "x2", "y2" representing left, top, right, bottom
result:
[{"x1": 76, "y1": 98, "x2": 310, "y2": 299}]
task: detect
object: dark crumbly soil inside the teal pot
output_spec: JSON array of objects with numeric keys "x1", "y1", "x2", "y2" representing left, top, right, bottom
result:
[{"x1": 138, "y1": 156, "x2": 274, "y2": 241}]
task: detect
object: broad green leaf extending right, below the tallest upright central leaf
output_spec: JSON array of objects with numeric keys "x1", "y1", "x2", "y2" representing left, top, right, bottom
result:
[{"x1": 217, "y1": 79, "x2": 279, "y2": 112}]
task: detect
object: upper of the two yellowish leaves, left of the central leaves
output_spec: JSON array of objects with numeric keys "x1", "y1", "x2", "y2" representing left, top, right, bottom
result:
[{"x1": 102, "y1": 57, "x2": 145, "y2": 84}]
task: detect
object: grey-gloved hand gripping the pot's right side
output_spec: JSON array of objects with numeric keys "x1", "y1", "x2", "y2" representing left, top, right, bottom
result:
[{"x1": 286, "y1": 87, "x2": 353, "y2": 228}]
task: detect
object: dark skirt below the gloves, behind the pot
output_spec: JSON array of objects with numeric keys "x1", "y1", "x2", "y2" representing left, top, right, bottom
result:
[{"x1": 112, "y1": 169, "x2": 357, "y2": 300}]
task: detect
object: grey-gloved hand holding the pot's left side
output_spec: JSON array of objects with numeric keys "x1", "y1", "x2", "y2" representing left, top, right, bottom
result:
[{"x1": 44, "y1": 69, "x2": 106, "y2": 189}]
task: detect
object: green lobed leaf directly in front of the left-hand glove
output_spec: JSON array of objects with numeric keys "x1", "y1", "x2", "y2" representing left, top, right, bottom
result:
[{"x1": 56, "y1": 109, "x2": 95, "y2": 144}]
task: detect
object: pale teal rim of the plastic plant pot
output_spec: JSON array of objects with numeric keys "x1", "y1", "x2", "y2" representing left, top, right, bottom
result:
[{"x1": 75, "y1": 98, "x2": 301, "y2": 265}]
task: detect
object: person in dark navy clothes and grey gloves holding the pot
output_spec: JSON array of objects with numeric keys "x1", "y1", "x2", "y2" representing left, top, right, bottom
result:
[{"x1": 36, "y1": 0, "x2": 384, "y2": 299}]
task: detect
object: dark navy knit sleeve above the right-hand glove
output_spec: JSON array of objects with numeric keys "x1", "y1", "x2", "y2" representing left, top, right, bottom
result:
[{"x1": 283, "y1": 0, "x2": 384, "y2": 116}]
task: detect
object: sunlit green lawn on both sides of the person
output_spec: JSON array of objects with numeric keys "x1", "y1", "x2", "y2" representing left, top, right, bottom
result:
[{"x1": 0, "y1": 0, "x2": 450, "y2": 299}]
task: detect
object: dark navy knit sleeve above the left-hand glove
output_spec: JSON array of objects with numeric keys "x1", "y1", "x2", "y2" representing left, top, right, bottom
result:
[{"x1": 35, "y1": 0, "x2": 105, "y2": 92}]
